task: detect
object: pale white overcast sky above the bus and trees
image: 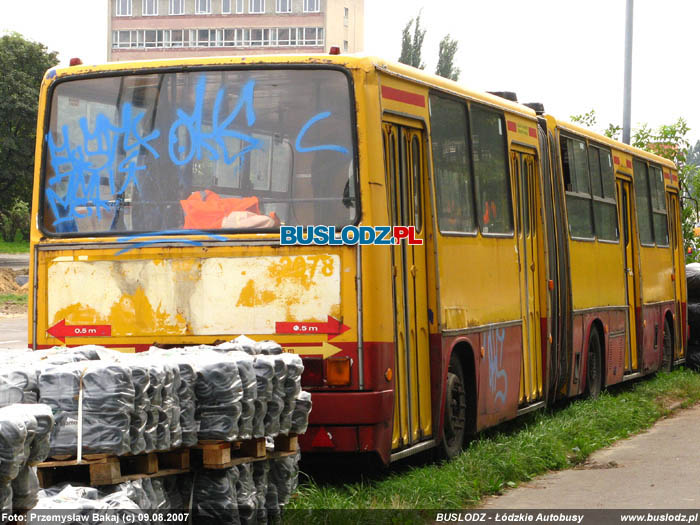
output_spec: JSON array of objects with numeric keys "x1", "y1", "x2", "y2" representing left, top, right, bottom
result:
[{"x1": 0, "y1": 0, "x2": 700, "y2": 141}]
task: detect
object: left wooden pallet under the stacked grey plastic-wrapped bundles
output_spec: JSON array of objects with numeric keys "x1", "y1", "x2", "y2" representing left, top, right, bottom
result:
[{"x1": 37, "y1": 448, "x2": 190, "y2": 488}]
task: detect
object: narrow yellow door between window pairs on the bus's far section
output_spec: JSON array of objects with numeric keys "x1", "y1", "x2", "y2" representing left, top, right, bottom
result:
[{"x1": 617, "y1": 179, "x2": 639, "y2": 374}]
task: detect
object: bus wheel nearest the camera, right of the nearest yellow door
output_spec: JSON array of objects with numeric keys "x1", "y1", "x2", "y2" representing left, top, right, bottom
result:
[{"x1": 441, "y1": 355, "x2": 467, "y2": 459}]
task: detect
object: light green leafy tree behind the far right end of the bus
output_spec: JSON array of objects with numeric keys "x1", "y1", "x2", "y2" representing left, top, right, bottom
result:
[{"x1": 571, "y1": 110, "x2": 700, "y2": 262}]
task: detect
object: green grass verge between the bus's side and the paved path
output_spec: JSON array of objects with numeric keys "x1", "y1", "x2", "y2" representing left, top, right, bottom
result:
[{"x1": 288, "y1": 370, "x2": 700, "y2": 510}]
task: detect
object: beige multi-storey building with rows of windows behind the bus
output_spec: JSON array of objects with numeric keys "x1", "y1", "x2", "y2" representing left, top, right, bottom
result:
[{"x1": 107, "y1": 0, "x2": 364, "y2": 61}]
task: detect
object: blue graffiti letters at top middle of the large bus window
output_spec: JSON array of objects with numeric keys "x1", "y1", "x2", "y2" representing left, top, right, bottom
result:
[{"x1": 168, "y1": 76, "x2": 262, "y2": 166}]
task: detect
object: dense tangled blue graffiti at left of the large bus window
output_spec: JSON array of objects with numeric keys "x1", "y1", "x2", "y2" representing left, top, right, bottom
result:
[{"x1": 46, "y1": 103, "x2": 160, "y2": 225}]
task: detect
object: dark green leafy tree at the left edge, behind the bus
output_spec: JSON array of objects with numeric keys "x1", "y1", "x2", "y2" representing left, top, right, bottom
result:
[{"x1": 0, "y1": 33, "x2": 58, "y2": 210}]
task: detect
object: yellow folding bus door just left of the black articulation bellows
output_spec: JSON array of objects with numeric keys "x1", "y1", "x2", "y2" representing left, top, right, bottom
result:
[{"x1": 511, "y1": 151, "x2": 546, "y2": 405}]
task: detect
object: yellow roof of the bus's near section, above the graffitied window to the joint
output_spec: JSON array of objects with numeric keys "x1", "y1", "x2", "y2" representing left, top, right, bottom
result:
[{"x1": 50, "y1": 54, "x2": 536, "y2": 118}]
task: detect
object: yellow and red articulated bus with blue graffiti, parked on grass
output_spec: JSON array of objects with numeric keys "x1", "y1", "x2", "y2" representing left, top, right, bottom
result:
[{"x1": 29, "y1": 55, "x2": 687, "y2": 463}]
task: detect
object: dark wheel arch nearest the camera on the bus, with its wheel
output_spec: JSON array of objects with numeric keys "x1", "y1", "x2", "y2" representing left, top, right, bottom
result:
[{"x1": 440, "y1": 342, "x2": 476, "y2": 459}]
